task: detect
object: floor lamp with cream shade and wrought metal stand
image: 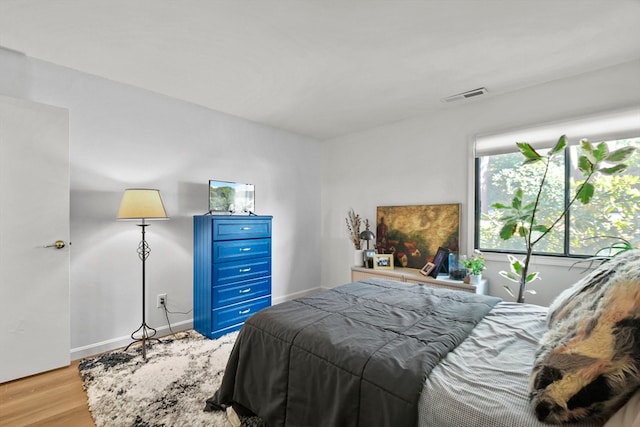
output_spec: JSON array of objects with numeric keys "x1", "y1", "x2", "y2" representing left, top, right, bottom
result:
[{"x1": 118, "y1": 188, "x2": 169, "y2": 360}]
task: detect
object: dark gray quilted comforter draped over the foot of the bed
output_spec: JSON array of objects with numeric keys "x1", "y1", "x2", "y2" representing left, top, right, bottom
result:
[{"x1": 208, "y1": 279, "x2": 500, "y2": 427}]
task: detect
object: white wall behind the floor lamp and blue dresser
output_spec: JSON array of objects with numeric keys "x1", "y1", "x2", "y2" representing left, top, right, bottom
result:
[{"x1": 0, "y1": 49, "x2": 320, "y2": 358}]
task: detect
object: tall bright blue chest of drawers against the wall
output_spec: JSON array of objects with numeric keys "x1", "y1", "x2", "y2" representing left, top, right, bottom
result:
[{"x1": 193, "y1": 215, "x2": 272, "y2": 338}]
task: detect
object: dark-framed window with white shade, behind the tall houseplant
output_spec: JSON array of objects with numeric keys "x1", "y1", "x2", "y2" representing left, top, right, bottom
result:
[{"x1": 475, "y1": 110, "x2": 640, "y2": 257}]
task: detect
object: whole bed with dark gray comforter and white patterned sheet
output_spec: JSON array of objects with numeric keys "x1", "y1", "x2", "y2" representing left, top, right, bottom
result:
[{"x1": 207, "y1": 252, "x2": 640, "y2": 427}]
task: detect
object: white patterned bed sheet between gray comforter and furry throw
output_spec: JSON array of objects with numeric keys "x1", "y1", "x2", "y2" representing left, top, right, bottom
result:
[{"x1": 418, "y1": 302, "x2": 603, "y2": 427}]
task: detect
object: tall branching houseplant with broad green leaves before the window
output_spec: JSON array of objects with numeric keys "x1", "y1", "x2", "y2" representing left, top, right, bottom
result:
[{"x1": 492, "y1": 135, "x2": 635, "y2": 303}]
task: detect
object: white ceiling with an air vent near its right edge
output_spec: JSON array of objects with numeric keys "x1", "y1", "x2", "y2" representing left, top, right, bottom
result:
[{"x1": 0, "y1": 0, "x2": 640, "y2": 139}]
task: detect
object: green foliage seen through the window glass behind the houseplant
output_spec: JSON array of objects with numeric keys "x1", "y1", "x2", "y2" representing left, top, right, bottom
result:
[{"x1": 477, "y1": 137, "x2": 640, "y2": 256}]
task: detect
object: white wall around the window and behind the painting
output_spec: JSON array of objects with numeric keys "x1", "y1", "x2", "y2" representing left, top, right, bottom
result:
[{"x1": 322, "y1": 61, "x2": 640, "y2": 305}]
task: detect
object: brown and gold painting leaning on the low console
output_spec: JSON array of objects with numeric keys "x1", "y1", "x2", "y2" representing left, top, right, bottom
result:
[{"x1": 376, "y1": 203, "x2": 460, "y2": 269}]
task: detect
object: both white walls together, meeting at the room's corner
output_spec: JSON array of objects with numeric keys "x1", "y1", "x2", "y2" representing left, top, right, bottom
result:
[{"x1": 0, "y1": 43, "x2": 640, "y2": 357}]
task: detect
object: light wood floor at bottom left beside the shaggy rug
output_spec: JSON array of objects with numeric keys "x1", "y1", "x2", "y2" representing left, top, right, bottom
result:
[{"x1": 0, "y1": 361, "x2": 95, "y2": 427}]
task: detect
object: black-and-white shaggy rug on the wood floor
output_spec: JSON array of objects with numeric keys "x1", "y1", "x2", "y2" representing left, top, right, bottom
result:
[{"x1": 79, "y1": 331, "x2": 256, "y2": 427}]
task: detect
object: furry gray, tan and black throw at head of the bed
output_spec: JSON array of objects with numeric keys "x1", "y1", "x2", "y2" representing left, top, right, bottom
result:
[{"x1": 531, "y1": 250, "x2": 640, "y2": 424}]
